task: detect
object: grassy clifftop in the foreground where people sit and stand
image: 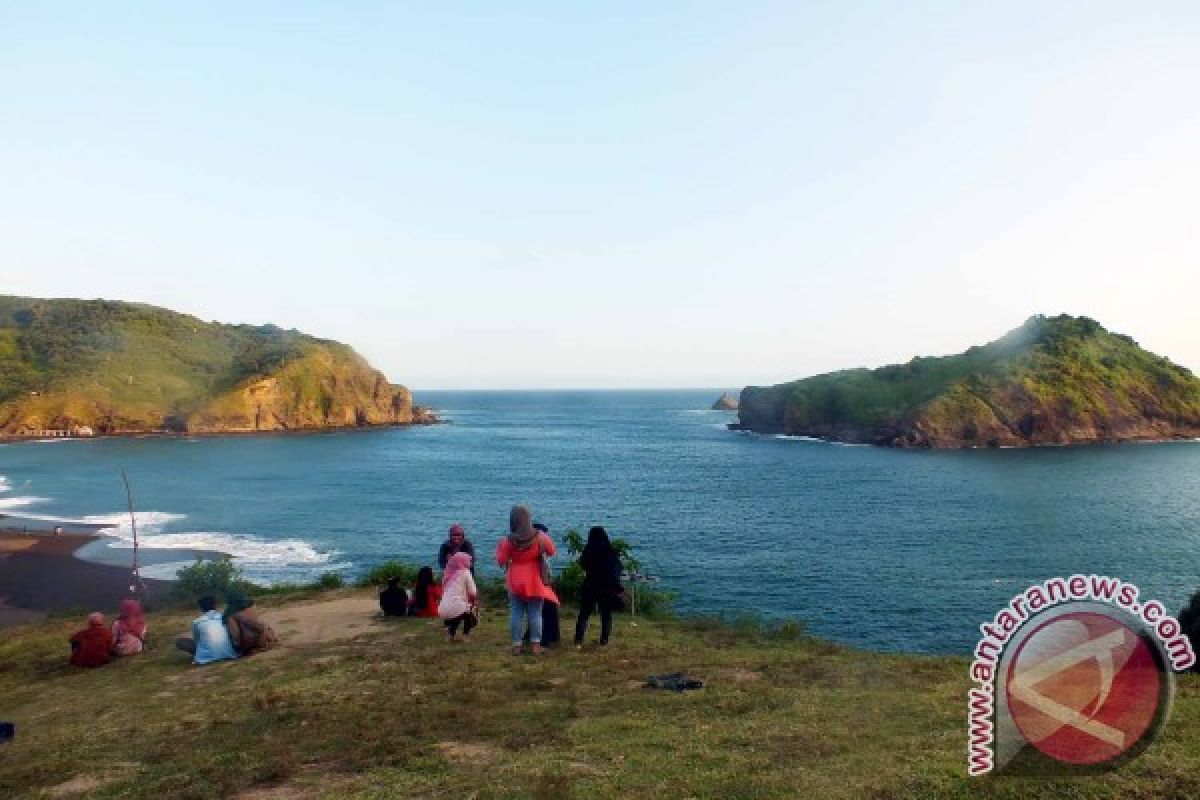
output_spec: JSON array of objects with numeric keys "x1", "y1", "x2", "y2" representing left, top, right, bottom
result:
[{"x1": 0, "y1": 590, "x2": 1200, "y2": 800}]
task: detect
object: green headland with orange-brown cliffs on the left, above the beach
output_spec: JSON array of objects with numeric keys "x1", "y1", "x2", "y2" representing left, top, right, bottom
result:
[{"x1": 0, "y1": 296, "x2": 421, "y2": 435}]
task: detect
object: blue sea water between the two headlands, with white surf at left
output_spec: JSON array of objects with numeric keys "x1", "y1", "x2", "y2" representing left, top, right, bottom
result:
[{"x1": 0, "y1": 390, "x2": 1200, "y2": 654}]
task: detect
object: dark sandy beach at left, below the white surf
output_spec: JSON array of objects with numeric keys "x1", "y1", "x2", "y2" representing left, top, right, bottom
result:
[{"x1": 0, "y1": 530, "x2": 170, "y2": 627}]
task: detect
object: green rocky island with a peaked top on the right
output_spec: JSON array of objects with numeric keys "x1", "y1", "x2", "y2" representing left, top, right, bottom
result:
[{"x1": 739, "y1": 314, "x2": 1200, "y2": 447}]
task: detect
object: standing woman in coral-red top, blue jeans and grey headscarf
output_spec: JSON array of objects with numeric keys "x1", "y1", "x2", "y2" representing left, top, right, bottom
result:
[{"x1": 496, "y1": 506, "x2": 558, "y2": 655}]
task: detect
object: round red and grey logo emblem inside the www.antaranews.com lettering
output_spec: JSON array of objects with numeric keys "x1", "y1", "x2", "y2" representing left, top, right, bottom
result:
[{"x1": 1006, "y1": 610, "x2": 1166, "y2": 765}]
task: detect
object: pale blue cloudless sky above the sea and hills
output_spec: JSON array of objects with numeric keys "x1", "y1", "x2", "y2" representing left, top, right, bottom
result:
[{"x1": 0, "y1": 0, "x2": 1200, "y2": 390}]
